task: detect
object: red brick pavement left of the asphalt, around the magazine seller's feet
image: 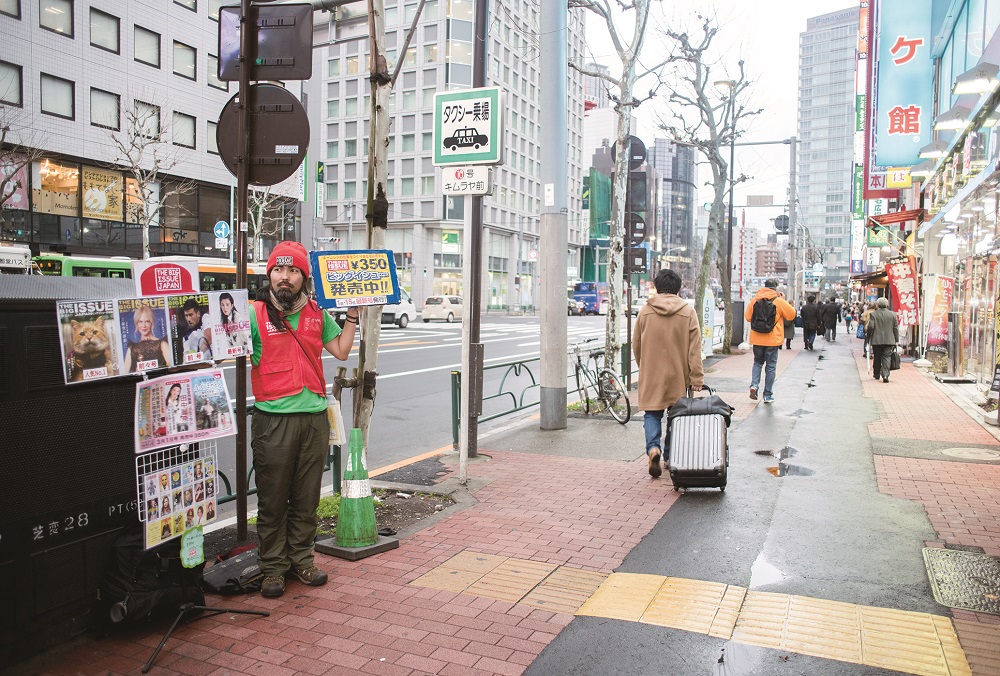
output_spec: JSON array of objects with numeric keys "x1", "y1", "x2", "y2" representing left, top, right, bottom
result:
[{"x1": 37, "y1": 450, "x2": 678, "y2": 676}]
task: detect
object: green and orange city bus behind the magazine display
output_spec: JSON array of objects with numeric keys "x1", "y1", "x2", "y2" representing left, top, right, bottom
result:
[{"x1": 35, "y1": 253, "x2": 267, "y2": 299}]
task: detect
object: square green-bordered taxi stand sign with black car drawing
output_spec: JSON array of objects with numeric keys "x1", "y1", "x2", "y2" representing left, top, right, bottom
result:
[{"x1": 434, "y1": 87, "x2": 505, "y2": 167}]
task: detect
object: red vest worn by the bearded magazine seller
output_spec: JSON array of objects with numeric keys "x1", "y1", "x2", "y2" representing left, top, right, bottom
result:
[{"x1": 250, "y1": 300, "x2": 326, "y2": 401}]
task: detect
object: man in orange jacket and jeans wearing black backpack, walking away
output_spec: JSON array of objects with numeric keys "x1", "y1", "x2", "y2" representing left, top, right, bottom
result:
[{"x1": 743, "y1": 279, "x2": 795, "y2": 404}]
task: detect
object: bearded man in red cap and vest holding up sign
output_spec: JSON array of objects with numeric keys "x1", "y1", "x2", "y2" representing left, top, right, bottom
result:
[{"x1": 250, "y1": 242, "x2": 358, "y2": 598}]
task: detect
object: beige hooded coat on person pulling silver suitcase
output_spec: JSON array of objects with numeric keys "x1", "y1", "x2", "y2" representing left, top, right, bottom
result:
[{"x1": 632, "y1": 293, "x2": 705, "y2": 411}]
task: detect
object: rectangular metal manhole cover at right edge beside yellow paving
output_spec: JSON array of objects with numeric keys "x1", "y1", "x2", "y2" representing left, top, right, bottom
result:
[{"x1": 924, "y1": 547, "x2": 1000, "y2": 615}]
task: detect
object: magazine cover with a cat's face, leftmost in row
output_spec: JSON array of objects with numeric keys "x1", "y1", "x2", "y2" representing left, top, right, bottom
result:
[{"x1": 56, "y1": 300, "x2": 121, "y2": 384}]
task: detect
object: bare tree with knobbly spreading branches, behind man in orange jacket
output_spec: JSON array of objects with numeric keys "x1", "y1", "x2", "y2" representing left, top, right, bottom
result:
[{"x1": 660, "y1": 15, "x2": 761, "y2": 353}]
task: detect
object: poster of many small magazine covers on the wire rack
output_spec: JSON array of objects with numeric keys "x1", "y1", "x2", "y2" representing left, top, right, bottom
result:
[{"x1": 141, "y1": 455, "x2": 218, "y2": 549}]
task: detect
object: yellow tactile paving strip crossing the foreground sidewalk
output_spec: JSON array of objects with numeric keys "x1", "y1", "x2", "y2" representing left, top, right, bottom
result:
[{"x1": 412, "y1": 551, "x2": 972, "y2": 676}]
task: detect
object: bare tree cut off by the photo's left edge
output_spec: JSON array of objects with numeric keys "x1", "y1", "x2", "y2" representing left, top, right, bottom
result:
[{"x1": 0, "y1": 106, "x2": 43, "y2": 239}]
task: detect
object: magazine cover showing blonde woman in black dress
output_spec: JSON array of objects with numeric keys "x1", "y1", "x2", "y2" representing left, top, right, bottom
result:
[{"x1": 118, "y1": 298, "x2": 174, "y2": 373}]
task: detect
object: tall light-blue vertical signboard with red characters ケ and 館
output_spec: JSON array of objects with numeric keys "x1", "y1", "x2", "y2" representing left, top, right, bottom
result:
[{"x1": 872, "y1": 0, "x2": 934, "y2": 172}]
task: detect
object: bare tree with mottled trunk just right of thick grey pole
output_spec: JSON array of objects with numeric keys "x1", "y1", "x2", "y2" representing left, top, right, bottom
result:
[{"x1": 569, "y1": 0, "x2": 670, "y2": 370}]
